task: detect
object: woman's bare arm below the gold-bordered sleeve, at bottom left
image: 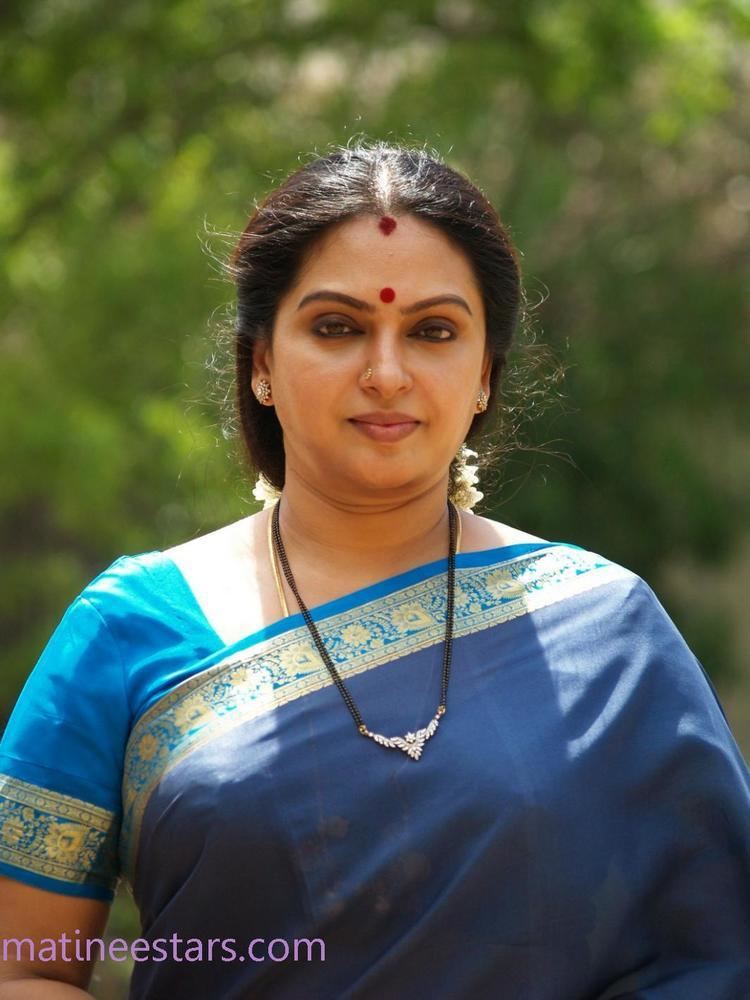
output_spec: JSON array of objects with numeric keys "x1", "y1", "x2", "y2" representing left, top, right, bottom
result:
[{"x1": 0, "y1": 876, "x2": 110, "y2": 1000}]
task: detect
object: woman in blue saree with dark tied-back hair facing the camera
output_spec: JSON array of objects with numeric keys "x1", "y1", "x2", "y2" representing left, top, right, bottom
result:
[{"x1": 0, "y1": 145, "x2": 750, "y2": 1000}]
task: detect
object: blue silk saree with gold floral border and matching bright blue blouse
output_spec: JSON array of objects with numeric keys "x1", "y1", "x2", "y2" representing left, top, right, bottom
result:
[{"x1": 0, "y1": 543, "x2": 750, "y2": 1000}]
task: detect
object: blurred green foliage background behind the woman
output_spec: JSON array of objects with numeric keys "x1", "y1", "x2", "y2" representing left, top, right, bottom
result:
[{"x1": 0, "y1": 0, "x2": 750, "y2": 998}]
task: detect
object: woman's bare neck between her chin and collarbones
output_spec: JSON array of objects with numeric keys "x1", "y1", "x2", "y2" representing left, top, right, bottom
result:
[{"x1": 279, "y1": 470, "x2": 456, "y2": 575}]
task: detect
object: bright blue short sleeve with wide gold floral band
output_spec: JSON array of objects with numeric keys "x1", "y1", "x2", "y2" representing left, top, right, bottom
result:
[{"x1": 0, "y1": 591, "x2": 130, "y2": 900}]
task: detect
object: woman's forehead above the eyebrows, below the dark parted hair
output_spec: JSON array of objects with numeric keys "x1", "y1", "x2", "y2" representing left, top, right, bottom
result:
[{"x1": 296, "y1": 215, "x2": 480, "y2": 301}]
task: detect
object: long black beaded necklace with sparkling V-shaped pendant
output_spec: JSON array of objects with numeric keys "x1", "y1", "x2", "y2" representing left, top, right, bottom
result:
[{"x1": 269, "y1": 500, "x2": 460, "y2": 760}]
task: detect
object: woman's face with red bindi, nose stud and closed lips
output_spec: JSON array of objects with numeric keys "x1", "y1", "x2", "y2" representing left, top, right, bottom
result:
[{"x1": 253, "y1": 216, "x2": 491, "y2": 504}]
